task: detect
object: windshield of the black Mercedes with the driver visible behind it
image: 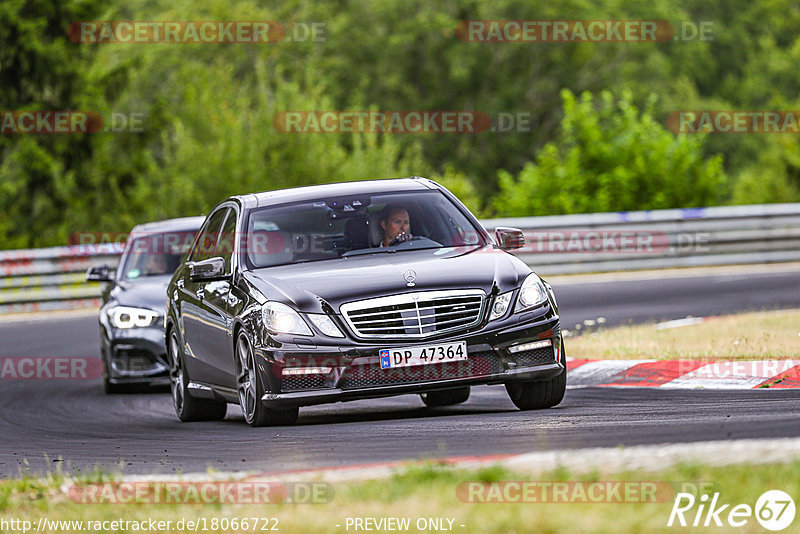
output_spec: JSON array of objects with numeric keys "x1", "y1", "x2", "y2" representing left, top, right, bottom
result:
[{"x1": 243, "y1": 191, "x2": 484, "y2": 269}]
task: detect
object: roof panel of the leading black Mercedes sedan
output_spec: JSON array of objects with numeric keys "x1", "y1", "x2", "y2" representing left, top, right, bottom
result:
[{"x1": 235, "y1": 176, "x2": 436, "y2": 208}]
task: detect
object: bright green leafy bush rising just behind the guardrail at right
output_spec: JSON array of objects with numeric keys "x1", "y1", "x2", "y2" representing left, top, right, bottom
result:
[{"x1": 493, "y1": 90, "x2": 725, "y2": 216}]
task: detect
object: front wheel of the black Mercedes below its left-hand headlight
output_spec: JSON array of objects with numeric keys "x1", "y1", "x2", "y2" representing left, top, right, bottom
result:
[{"x1": 236, "y1": 331, "x2": 300, "y2": 426}]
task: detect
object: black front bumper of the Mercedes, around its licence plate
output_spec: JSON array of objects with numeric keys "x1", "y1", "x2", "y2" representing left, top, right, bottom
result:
[{"x1": 256, "y1": 312, "x2": 564, "y2": 408}]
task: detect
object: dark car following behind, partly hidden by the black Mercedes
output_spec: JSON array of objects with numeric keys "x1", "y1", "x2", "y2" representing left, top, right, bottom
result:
[{"x1": 86, "y1": 217, "x2": 204, "y2": 393}]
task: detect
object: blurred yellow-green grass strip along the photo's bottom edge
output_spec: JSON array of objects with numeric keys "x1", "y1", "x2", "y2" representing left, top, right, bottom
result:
[{"x1": 6, "y1": 461, "x2": 800, "y2": 534}]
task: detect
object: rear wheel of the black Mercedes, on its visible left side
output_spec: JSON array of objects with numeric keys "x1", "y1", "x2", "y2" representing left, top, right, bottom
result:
[{"x1": 167, "y1": 330, "x2": 228, "y2": 423}]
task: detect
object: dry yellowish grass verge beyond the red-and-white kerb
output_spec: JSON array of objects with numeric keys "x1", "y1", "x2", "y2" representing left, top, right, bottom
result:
[{"x1": 566, "y1": 310, "x2": 800, "y2": 360}]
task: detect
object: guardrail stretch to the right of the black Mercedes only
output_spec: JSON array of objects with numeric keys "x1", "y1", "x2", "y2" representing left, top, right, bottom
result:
[{"x1": 482, "y1": 204, "x2": 800, "y2": 274}]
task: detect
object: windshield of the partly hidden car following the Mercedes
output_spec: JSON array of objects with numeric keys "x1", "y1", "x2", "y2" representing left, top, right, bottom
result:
[{"x1": 121, "y1": 231, "x2": 195, "y2": 280}]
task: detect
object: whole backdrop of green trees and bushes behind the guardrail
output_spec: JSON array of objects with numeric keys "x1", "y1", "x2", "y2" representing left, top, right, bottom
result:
[{"x1": 0, "y1": 0, "x2": 800, "y2": 248}]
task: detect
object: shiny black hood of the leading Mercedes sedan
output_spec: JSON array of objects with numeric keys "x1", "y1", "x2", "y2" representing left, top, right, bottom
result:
[{"x1": 245, "y1": 246, "x2": 531, "y2": 313}]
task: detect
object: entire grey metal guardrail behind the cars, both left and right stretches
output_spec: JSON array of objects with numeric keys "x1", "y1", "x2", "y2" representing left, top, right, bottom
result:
[{"x1": 0, "y1": 204, "x2": 800, "y2": 313}]
